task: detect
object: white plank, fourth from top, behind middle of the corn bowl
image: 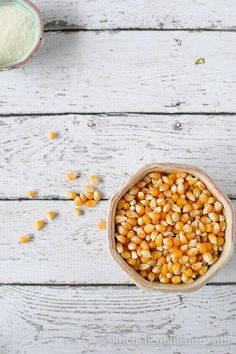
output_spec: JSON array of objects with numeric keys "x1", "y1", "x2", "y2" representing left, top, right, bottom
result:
[{"x1": 0, "y1": 201, "x2": 236, "y2": 284}]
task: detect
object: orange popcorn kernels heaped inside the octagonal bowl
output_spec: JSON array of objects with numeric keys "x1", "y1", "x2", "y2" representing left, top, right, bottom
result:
[{"x1": 115, "y1": 172, "x2": 226, "y2": 284}]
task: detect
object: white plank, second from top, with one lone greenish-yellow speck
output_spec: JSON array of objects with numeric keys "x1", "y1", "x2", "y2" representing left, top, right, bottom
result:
[{"x1": 0, "y1": 31, "x2": 236, "y2": 114}]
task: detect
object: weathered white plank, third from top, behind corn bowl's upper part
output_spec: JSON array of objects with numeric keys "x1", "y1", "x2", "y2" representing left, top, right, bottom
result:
[{"x1": 0, "y1": 115, "x2": 236, "y2": 198}]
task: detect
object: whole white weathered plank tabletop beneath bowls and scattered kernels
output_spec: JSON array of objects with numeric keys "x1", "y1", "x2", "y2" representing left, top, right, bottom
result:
[{"x1": 0, "y1": 0, "x2": 236, "y2": 354}]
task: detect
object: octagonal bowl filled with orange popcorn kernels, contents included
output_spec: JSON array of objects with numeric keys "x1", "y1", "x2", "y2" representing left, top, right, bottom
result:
[{"x1": 107, "y1": 163, "x2": 234, "y2": 292}]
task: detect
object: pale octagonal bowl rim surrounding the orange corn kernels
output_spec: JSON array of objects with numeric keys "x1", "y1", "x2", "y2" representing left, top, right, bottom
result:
[{"x1": 107, "y1": 163, "x2": 234, "y2": 292}]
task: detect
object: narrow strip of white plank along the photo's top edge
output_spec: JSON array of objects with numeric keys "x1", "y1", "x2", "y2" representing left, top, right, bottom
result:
[{"x1": 35, "y1": 0, "x2": 236, "y2": 30}]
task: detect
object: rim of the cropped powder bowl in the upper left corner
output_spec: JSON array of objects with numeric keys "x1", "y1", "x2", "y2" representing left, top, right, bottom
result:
[{"x1": 0, "y1": 0, "x2": 44, "y2": 71}]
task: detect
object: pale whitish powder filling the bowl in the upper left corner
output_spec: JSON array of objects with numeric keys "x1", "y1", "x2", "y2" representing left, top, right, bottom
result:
[{"x1": 0, "y1": 0, "x2": 36, "y2": 66}]
